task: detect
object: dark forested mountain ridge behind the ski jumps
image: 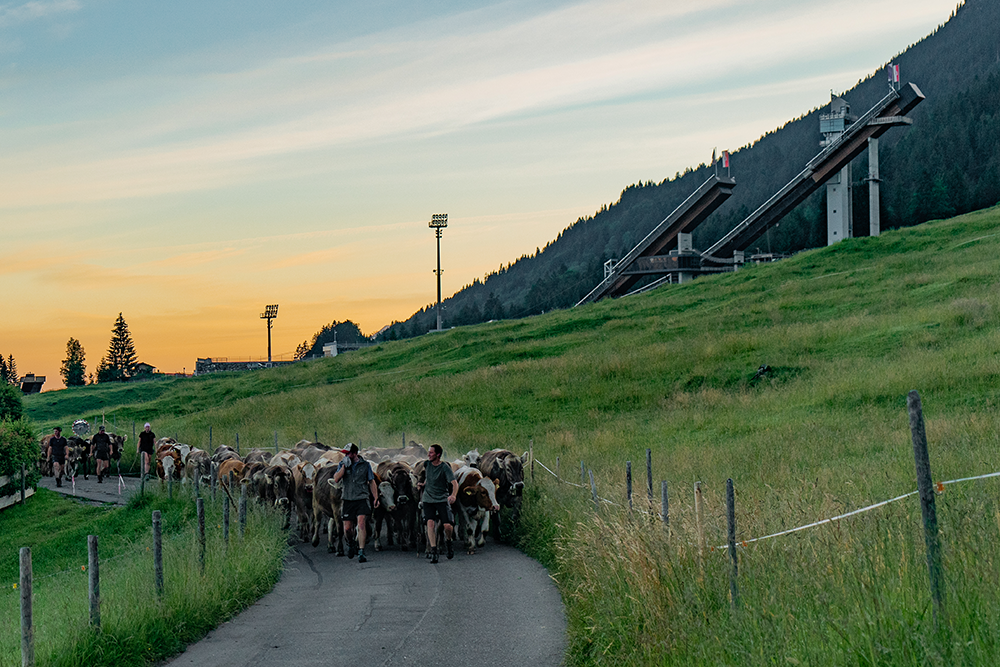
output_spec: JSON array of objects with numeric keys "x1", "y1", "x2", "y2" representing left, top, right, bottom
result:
[{"x1": 379, "y1": 0, "x2": 1000, "y2": 340}]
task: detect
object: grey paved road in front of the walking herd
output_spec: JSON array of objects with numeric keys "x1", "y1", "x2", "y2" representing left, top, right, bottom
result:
[{"x1": 166, "y1": 539, "x2": 566, "y2": 667}]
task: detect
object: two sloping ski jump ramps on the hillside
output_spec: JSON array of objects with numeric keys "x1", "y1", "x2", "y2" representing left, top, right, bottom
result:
[{"x1": 576, "y1": 83, "x2": 924, "y2": 306}]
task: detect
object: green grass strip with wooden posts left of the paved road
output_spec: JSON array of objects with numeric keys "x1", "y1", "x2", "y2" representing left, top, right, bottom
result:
[{"x1": 0, "y1": 489, "x2": 286, "y2": 666}]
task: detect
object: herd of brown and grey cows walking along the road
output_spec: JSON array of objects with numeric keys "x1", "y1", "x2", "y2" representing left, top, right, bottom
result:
[{"x1": 42, "y1": 434, "x2": 527, "y2": 556}]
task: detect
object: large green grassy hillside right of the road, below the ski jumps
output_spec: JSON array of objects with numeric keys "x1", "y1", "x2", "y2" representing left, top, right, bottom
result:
[{"x1": 26, "y1": 208, "x2": 1000, "y2": 664}]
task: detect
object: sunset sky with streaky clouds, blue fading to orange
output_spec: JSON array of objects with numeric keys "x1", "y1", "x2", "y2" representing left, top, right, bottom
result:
[{"x1": 0, "y1": 0, "x2": 956, "y2": 390}]
